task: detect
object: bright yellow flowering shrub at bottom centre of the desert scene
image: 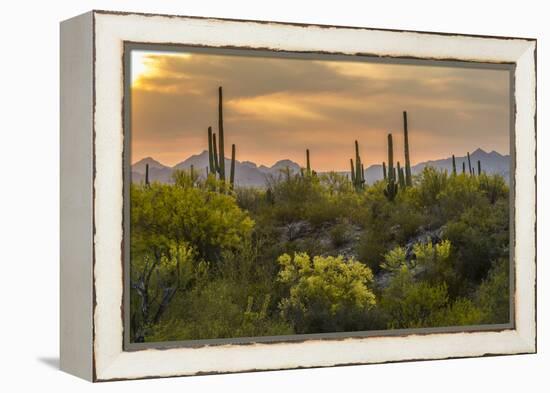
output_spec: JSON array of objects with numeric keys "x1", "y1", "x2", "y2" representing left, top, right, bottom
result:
[{"x1": 278, "y1": 253, "x2": 376, "y2": 333}]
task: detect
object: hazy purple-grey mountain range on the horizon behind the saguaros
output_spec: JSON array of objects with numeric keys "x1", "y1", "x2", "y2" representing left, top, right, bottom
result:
[{"x1": 132, "y1": 149, "x2": 510, "y2": 187}]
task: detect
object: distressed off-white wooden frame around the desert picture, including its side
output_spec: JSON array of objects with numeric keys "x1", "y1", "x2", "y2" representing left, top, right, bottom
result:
[{"x1": 60, "y1": 11, "x2": 536, "y2": 381}]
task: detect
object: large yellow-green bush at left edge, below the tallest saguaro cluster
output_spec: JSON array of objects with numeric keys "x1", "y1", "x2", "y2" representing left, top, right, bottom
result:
[{"x1": 130, "y1": 183, "x2": 254, "y2": 261}]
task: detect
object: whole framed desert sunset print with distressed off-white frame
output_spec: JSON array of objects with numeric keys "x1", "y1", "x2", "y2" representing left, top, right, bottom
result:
[{"x1": 61, "y1": 11, "x2": 536, "y2": 381}]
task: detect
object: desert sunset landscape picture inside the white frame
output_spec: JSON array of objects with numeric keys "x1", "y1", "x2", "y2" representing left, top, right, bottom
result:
[{"x1": 126, "y1": 49, "x2": 513, "y2": 343}]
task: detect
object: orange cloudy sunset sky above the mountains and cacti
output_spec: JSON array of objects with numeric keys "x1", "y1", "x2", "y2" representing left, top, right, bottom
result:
[{"x1": 131, "y1": 50, "x2": 510, "y2": 171}]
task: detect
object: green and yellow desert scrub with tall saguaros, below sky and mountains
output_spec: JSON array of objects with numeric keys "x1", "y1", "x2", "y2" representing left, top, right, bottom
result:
[{"x1": 130, "y1": 88, "x2": 509, "y2": 342}]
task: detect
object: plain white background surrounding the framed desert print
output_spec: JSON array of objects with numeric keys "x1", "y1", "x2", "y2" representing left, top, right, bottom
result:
[{"x1": 0, "y1": 0, "x2": 550, "y2": 393}]
